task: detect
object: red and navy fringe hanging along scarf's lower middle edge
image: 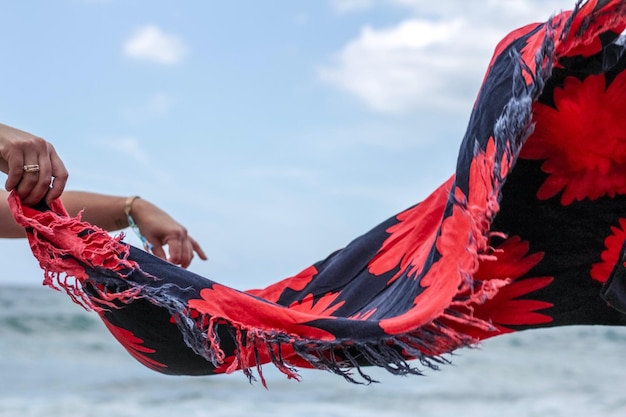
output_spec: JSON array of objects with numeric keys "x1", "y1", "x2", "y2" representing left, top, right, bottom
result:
[{"x1": 163, "y1": 290, "x2": 496, "y2": 388}]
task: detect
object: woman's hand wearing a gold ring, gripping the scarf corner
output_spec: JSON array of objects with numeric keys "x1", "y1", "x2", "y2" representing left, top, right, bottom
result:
[{"x1": 0, "y1": 124, "x2": 68, "y2": 206}]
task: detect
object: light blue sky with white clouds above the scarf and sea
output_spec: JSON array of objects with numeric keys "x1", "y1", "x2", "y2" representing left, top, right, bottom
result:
[{"x1": 0, "y1": 0, "x2": 575, "y2": 289}]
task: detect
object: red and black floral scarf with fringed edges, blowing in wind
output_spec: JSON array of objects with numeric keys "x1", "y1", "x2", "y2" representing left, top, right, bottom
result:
[{"x1": 10, "y1": 0, "x2": 626, "y2": 381}]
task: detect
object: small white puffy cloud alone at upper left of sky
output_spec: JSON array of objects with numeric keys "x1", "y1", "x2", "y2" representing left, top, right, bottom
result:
[{"x1": 124, "y1": 25, "x2": 188, "y2": 65}]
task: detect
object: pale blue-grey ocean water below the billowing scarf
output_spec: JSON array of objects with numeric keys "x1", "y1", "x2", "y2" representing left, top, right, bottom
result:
[{"x1": 0, "y1": 286, "x2": 626, "y2": 417}]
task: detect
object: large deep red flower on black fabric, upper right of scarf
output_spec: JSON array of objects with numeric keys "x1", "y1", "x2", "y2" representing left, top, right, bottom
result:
[{"x1": 520, "y1": 72, "x2": 626, "y2": 205}]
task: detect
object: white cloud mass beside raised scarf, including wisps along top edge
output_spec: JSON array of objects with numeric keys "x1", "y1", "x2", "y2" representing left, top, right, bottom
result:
[{"x1": 318, "y1": 0, "x2": 571, "y2": 113}]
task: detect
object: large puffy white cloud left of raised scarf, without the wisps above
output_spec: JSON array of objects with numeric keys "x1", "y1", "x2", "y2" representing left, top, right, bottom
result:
[{"x1": 319, "y1": 18, "x2": 500, "y2": 113}]
